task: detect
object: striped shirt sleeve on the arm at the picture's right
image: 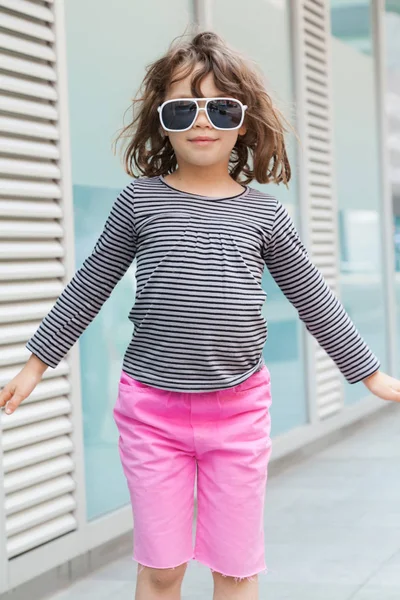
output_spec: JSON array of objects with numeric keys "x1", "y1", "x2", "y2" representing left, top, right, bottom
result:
[{"x1": 263, "y1": 201, "x2": 380, "y2": 383}]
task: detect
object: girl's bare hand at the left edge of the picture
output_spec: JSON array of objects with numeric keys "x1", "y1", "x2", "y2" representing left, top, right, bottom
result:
[{"x1": 0, "y1": 355, "x2": 47, "y2": 415}]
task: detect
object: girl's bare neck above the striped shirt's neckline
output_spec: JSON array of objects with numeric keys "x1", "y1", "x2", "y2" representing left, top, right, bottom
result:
[{"x1": 164, "y1": 169, "x2": 243, "y2": 197}]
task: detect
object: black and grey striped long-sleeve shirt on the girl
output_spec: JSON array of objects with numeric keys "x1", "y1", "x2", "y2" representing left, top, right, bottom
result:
[{"x1": 27, "y1": 176, "x2": 380, "y2": 392}]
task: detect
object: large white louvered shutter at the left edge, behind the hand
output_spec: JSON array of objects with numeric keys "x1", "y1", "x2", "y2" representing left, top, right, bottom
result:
[{"x1": 0, "y1": 0, "x2": 76, "y2": 558}]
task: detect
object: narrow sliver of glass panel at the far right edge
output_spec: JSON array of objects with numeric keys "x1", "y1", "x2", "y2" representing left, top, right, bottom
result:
[{"x1": 384, "y1": 0, "x2": 400, "y2": 377}]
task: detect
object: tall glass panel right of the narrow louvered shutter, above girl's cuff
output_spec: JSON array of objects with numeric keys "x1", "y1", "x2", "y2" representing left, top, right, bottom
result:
[{"x1": 331, "y1": 0, "x2": 386, "y2": 403}]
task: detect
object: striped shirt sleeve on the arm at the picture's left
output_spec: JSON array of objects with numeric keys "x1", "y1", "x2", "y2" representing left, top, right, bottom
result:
[{"x1": 26, "y1": 183, "x2": 136, "y2": 368}]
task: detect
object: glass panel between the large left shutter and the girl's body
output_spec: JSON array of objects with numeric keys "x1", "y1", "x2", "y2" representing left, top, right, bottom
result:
[{"x1": 65, "y1": 0, "x2": 193, "y2": 520}]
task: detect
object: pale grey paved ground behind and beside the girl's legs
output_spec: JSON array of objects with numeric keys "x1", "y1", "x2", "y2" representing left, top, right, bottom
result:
[{"x1": 47, "y1": 405, "x2": 400, "y2": 600}]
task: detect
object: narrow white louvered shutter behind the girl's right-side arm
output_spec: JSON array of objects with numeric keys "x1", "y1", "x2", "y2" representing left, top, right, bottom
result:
[{"x1": 298, "y1": 0, "x2": 343, "y2": 419}]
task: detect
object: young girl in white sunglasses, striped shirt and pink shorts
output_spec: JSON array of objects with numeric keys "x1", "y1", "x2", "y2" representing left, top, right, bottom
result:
[{"x1": 0, "y1": 32, "x2": 400, "y2": 600}]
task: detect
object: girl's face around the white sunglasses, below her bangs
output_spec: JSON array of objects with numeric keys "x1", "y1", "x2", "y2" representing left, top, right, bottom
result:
[{"x1": 164, "y1": 66, "x2": 246, "y2": 167}]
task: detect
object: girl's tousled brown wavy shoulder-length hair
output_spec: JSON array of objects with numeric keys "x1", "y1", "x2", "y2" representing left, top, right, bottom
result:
[{"x1": 116, "y1": 31, "x2": 293, "y2": 186}]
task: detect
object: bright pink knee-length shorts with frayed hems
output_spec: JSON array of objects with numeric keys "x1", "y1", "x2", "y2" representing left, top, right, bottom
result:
[{"x1": 113, "y1": 366, "x2": 272, "y2": 579}]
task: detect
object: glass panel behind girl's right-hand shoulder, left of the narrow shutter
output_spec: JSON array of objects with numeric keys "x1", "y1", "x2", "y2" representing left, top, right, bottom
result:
[{"x1": 213, "y1": 0, "x2": 308, "y2": 436}]
